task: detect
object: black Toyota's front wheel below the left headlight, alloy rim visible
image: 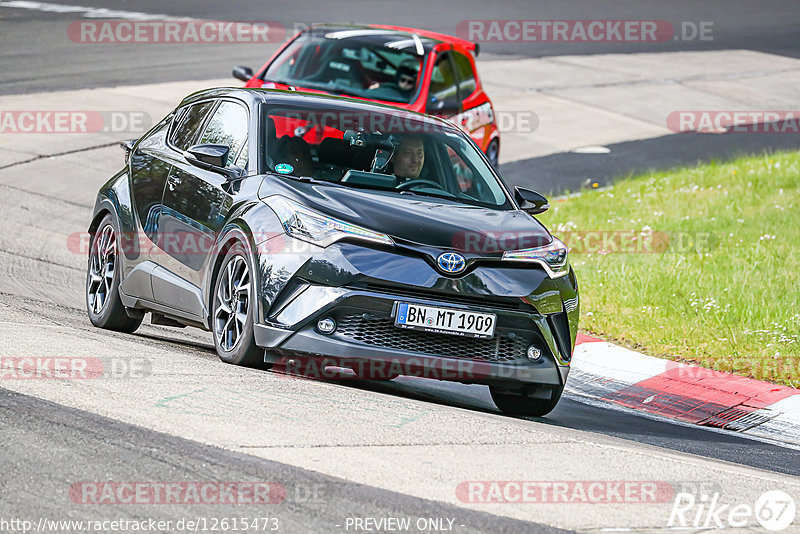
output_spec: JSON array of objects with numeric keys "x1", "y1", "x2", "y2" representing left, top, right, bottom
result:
[{"x1": 211, "y1": 242, "x2": 265, "y2": 368}]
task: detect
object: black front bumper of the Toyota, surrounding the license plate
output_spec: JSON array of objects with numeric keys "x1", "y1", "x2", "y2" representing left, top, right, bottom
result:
[{"x1": 255, "y1": 281, "x2": 572, "y2": 388}]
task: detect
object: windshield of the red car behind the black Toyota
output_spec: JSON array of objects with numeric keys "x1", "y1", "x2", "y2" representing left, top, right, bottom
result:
[{"x1": 264, "y1": 30, "x2": 423, "y2": 104}]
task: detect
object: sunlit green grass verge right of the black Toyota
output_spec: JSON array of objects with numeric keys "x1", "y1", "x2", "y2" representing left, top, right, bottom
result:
[{"x1": 539, "y1": 152, "x2": 800, "y2": 387}]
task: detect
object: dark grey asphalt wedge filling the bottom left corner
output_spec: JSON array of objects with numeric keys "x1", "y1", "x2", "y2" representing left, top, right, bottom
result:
[{"x1": 0, "y1": 389, "x2": 566, "y2": 534}]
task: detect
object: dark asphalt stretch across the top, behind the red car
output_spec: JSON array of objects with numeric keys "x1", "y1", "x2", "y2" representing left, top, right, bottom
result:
[{"x1": 0, "y1": 0, "x2": 800, "y2": 94}]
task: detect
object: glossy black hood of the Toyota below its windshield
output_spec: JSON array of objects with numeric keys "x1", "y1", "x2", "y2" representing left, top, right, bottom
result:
[{"x1": 259, "y1": 176, "x2": 553, "y2": 255}]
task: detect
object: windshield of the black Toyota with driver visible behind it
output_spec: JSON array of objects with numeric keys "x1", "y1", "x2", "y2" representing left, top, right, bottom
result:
[{"x1": 264, "y1": 102, "x2": 511, "y2": 209}]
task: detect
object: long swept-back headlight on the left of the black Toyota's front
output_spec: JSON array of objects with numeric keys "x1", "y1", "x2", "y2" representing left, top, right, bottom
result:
[{"x1": 266, "y1": 195, "x2": 394, "y2": 247}]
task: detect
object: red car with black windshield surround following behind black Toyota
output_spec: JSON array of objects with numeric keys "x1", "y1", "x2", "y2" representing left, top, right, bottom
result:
[{"x1": 228, "y1": 24, "x2": 500, "y2": 168}]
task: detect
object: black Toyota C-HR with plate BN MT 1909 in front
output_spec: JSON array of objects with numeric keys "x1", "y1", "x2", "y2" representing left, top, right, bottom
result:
[{"x1": 86, "y1": 89, "x2": 579, "y2": 415}]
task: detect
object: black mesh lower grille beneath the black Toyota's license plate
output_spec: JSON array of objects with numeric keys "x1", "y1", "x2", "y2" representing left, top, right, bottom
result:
[{"x1": 336, "y1": 315, "x2": 530, "y2": 363}]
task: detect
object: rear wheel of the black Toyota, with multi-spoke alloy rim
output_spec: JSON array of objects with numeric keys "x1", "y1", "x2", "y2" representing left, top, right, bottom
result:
[{"x1": 84, "y1": 214, "x2": 144, "y2": 334}]
